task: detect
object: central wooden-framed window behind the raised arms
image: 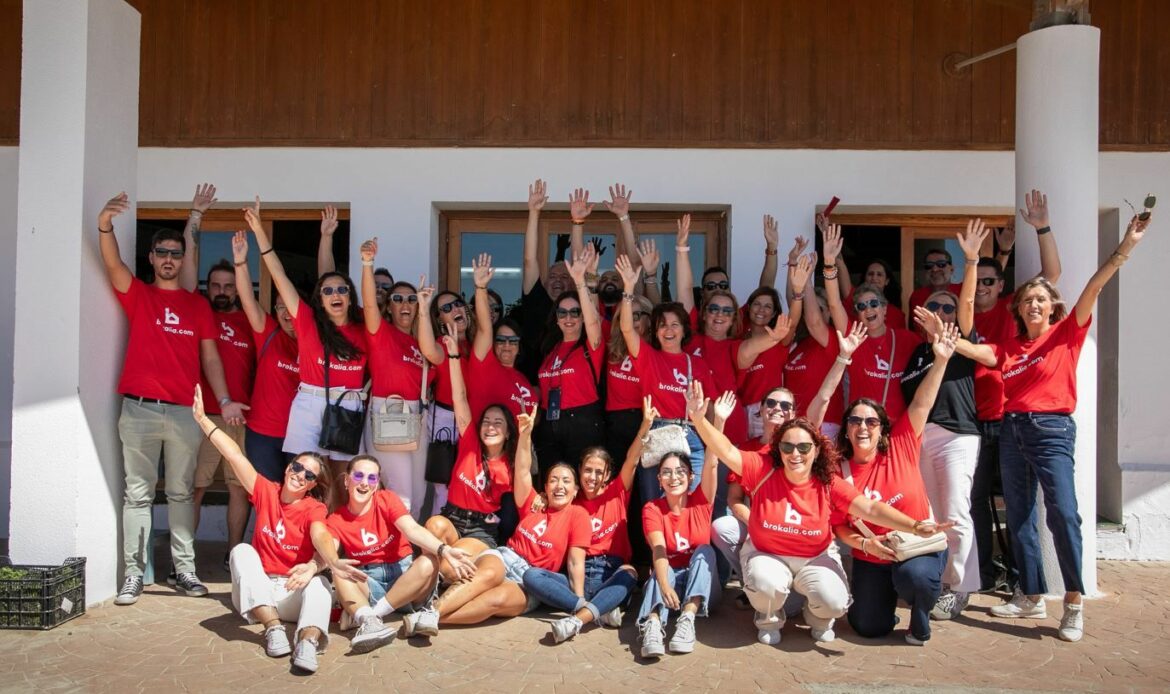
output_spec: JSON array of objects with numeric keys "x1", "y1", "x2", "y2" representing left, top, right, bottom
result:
[{"x1": 439, "y1": 209, "x2": 727, "y2": 305}]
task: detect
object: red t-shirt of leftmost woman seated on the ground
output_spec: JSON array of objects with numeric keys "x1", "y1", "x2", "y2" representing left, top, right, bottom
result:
[{"x1": 250, "y1": 475, "x2": 325, "y2": 576}]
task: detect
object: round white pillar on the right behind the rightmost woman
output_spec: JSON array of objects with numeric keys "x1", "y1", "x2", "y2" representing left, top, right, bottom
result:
[{"x1": 1016, "y1": 26, "x2": 1101, "y2": 595}]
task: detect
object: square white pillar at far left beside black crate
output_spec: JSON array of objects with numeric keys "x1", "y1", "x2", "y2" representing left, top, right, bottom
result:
[{"x1": 9, "y1": 0, "x2": 140, "y2": 603}]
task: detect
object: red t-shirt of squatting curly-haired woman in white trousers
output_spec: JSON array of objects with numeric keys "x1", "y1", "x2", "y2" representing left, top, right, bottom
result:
[{"x1": 741, "y1": 451, "x2": 861, "y2": 557}]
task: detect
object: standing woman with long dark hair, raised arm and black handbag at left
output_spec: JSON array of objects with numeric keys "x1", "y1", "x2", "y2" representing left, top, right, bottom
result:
[{"x1": 243, "y1": 195, "x2": 369, "y2": 477}]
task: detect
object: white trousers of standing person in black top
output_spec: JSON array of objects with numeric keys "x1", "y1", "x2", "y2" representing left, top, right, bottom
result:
[{"x1": 918, "y1": 424, "x2": 979, "y2": 593}]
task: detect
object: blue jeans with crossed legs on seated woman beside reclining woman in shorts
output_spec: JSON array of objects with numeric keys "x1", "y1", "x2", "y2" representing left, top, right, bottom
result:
[{"x1": 524, "y1": 555, "x2": 636, "y2": 621}]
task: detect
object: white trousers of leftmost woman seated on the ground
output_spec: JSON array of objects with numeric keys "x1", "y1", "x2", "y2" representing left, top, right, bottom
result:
[{"x1": 230, "y1": 542, "x2": 333, "y2": 653}]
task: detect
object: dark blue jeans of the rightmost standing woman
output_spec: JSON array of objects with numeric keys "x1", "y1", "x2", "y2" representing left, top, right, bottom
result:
[{"x1": 999, "y1": 412, "x2": 1085, "y2": 596}]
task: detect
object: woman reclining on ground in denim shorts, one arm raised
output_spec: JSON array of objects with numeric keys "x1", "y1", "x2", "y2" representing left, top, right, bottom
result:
[{"x1": 406, "y1": 400, "x2": 591, "y2": 635}]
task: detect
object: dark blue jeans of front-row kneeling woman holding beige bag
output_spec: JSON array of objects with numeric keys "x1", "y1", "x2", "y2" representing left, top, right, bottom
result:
[{"x1": 849, "y1": 551, "x2": 947, "y2": 641}]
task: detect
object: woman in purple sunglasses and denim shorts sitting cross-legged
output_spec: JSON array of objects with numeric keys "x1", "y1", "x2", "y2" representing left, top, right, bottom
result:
[{"x1": 312, "y1": 451, "x2": 475, "y2": 653}]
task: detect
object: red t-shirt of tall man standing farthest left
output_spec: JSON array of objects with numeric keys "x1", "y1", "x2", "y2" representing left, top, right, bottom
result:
[{"x1": 113, "y1": 277, "x2": 216, "y2": 405}]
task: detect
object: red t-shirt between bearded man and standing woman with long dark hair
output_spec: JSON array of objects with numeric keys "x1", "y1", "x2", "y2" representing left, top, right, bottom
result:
[{"x1": 247, "y1": 316, "x2": 301, "y2": 439}]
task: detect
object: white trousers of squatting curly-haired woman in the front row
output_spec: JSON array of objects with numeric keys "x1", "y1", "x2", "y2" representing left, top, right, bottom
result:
[{"x1": 739, "y1": 537, "x2": 851, "y2": 628}]
